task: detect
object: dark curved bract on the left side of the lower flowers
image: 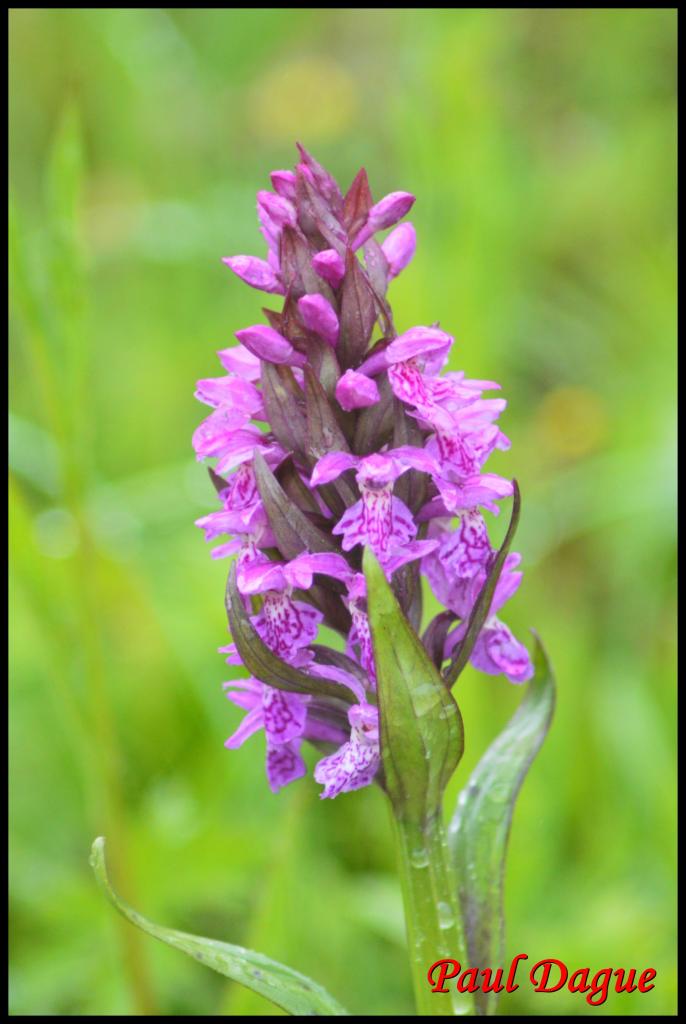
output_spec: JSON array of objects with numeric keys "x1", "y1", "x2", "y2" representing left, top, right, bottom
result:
[{"x1": 226, "y1": 564, "x2": 356, "y2": 703}]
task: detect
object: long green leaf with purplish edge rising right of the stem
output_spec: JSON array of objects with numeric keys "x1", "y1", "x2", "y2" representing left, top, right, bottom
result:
[{"x1": 448, "y1": 634, "x2": 555, "y2": 1014}]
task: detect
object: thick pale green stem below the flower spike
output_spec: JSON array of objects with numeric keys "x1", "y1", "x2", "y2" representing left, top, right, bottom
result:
[{"x1": 393, "y1": 816, "x2": 475, "y2": 1017}]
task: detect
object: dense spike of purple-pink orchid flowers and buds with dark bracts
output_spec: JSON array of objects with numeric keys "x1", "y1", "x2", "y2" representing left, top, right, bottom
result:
[{"x1": 194, "y1": 145, "x2": 532, "y2": 797}]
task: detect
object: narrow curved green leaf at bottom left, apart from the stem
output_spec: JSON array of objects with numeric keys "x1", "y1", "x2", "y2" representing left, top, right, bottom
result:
[{"x1": 90, "y1": 837, "x2": 347, "y2": 1017}]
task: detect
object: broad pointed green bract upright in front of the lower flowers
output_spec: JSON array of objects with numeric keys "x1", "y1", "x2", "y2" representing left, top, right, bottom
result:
[{"x1": 363, "y1": 549, "x2": 464, "y2": 823}]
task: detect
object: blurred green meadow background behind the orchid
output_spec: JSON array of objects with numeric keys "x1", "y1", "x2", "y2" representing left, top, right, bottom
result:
[{"x1": 10, "y1": 8, "x2": 676, "y2": 1016}]
